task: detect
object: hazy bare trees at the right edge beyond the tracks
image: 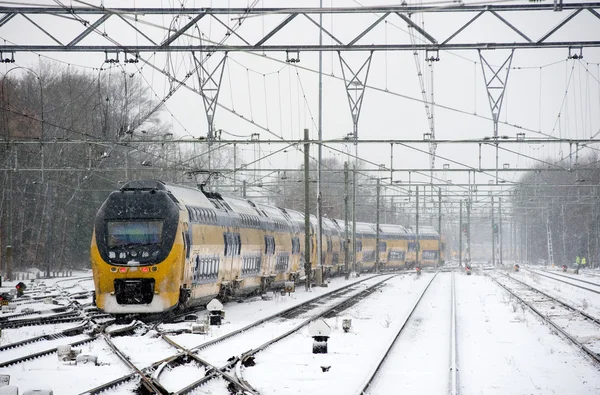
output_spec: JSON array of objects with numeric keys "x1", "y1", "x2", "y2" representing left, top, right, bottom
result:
[{"x1": 512, "y1": 150, "x2": 600, "y2": 266}]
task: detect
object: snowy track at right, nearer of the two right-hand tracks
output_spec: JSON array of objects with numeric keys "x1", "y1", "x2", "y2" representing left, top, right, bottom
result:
[{"x1": 490, "y1": 275, "x2": 600, "y2": 363}]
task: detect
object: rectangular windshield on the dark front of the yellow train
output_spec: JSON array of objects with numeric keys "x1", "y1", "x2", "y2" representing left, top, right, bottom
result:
[{"x1": 107, "y1": 221, "x2": 163, "y2": 248}]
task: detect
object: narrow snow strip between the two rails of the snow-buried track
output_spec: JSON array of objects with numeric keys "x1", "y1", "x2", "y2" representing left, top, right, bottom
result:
[{"x1": 368, "y1": 273, "x2": 452, "y2": 395}]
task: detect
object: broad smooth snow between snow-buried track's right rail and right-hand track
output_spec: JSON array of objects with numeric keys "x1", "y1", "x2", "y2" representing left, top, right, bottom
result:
[{"x1": 456, "y1": 275, "x2": 600, "y2": 395}]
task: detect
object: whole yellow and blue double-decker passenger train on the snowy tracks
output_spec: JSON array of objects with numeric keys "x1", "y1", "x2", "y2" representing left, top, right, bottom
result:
[{"x1": 90, "y1": 180, "x2": 444, "y2": 315}]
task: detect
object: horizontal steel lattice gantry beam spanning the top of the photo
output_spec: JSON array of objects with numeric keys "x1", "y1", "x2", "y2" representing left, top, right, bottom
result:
[{"x1": 0, "y1": 0, "x2": 600, "y2": 53}]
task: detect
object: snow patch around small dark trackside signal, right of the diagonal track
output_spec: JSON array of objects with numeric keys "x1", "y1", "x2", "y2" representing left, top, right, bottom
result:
[{"x1": 244, "y1": 274, "x2": 433, "y2": 395}]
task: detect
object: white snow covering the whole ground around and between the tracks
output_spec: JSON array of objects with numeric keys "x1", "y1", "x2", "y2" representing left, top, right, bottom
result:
[{"x1": 0, "y1": 272, "x2": 600, "y2": 395}]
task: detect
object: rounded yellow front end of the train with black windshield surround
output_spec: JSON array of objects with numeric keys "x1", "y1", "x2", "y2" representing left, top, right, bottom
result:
[{"x1": 91, "y1": 181, "x2": 185, "y2": 315}]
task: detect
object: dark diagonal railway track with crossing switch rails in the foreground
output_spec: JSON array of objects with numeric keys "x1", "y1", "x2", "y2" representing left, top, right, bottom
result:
[{"x1": 84, "y1": 275, "x2": 394, "y2": 394}]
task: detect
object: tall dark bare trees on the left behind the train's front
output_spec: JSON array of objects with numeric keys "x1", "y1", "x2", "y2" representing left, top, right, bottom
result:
[{"x1": 0, "y1": 64, "x2": 231, "y2": 276}]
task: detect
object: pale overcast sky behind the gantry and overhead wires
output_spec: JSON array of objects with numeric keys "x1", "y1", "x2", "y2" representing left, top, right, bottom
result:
[{"x1": 0, "y1": 0, "x2": 600, "y2": 195}]
